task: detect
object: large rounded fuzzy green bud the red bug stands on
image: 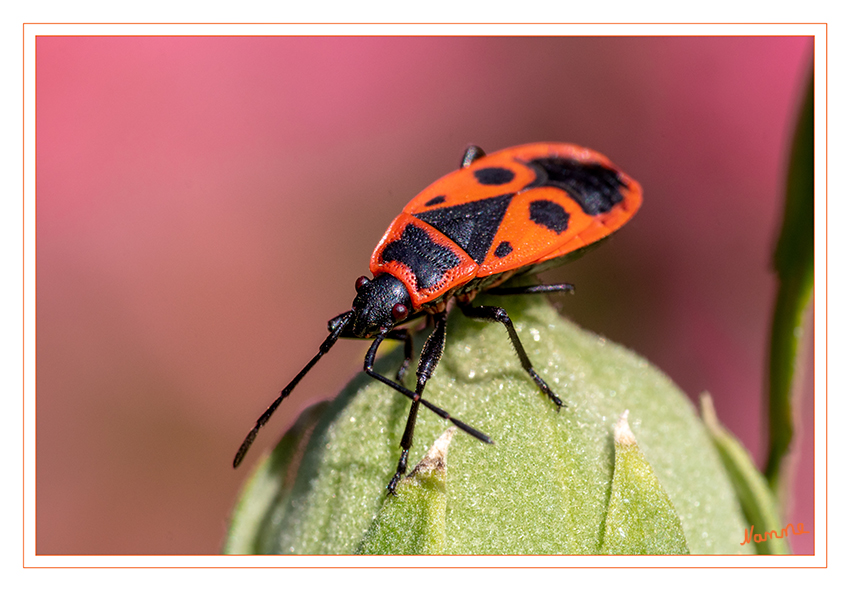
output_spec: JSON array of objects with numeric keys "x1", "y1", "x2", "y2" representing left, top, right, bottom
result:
[{"x1": 228, "y1": 296, "x2": 754, "y2": 554}]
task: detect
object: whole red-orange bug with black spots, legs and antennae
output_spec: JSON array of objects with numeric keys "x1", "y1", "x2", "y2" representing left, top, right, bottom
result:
[{"x1": 233, "y1": 143, "x2": 642, "y2": 493}]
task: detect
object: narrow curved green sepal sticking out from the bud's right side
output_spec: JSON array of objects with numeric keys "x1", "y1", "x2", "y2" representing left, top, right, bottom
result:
[{"x1": 700, "y1": 394, "x2": 791, "y2": 554}]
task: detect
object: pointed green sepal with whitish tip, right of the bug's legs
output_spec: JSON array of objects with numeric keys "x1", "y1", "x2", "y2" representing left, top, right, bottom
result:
[{"x1": 600, "y1": 411, "x2": 689, "y2": 554}]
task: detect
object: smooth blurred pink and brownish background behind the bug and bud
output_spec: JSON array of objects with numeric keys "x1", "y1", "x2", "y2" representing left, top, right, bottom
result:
[{"x1": 36, "y1": 37, "x2": 814, "y2": 554}]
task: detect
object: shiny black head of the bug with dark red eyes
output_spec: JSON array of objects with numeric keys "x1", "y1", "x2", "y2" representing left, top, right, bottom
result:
[{"x1": 346, "y1": 273, "x2": 412, "y2": 338}]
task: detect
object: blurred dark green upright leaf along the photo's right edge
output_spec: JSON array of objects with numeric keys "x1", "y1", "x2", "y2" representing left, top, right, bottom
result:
[{"x1": 765, "y1": 75, "x2": 815, "y2": 493}]
